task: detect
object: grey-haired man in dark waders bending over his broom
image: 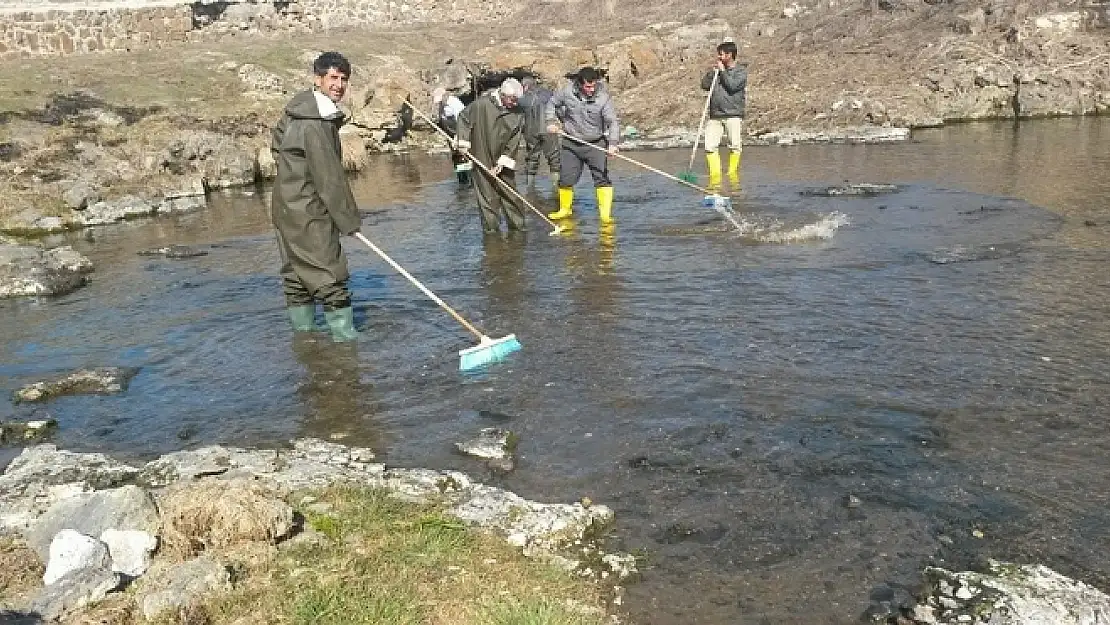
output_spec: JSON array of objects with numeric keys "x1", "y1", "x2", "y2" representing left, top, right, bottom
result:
[{"x1": 456, "y1": 78, "x2": 524, "y2": 234}]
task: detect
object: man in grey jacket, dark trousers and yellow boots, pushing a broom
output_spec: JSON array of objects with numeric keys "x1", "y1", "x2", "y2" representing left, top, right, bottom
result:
[{"x1": 544, "y1": 68, "x2": 620, "y2": 223}]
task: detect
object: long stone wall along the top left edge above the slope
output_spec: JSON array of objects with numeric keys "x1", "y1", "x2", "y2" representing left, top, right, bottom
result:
[{"x1": 0, "y1": 0, "x2": 517, "y2": 59}]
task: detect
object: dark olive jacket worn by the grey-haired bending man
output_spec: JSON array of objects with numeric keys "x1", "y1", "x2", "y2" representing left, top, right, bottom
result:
[{"x1": 458, "y1": 89, "x2": 524, "y2": 170}]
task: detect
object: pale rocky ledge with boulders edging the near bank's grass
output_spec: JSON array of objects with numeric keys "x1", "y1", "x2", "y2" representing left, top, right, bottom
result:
[{"x1": 0, "y1": 440, "x2": 635, "y2": 618}]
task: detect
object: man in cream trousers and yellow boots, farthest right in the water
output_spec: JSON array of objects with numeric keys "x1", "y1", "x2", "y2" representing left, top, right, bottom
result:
[{"x1": 702, "y1": 39, "x2": 748, "y2": 185}]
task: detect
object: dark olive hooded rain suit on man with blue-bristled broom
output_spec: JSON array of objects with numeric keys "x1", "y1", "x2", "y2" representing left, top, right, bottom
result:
[{"x1": 270, "y1": 90, "x2": 362, "y2": 292}]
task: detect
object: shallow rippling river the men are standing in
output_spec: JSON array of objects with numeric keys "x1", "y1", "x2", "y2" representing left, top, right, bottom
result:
[{"x1": 0, "y1": 119, "x2": 1110, "y2": 625}]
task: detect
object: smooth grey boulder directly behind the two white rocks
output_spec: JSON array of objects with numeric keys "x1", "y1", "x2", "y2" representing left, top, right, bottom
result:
[{"x1": 24, "y1": 485, "x2": 162, "y2": 558}]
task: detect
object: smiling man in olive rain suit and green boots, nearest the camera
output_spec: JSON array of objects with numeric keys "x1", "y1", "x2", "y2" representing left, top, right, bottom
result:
[{"x1": 270, "y1": 52, "x2": 362, "y2": 342}]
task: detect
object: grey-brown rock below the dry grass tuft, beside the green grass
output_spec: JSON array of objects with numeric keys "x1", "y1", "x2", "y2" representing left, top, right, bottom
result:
[{"x1": 135, "y1": 557, "x2": 231, "y2": 619}]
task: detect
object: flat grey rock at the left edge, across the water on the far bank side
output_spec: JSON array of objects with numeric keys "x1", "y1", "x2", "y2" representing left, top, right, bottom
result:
[{"x1": 0, "y1": 245, "x2": 92, "y2": 298}]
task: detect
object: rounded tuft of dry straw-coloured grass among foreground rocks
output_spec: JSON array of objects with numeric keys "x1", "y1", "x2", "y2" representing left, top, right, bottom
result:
[{"x1": 159, "y1": 480, "x2": 293, "y2": 557}]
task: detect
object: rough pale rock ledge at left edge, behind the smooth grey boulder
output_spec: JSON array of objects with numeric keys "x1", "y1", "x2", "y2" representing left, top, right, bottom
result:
[{"x1": 0, "y1": 444, "x2": 139, "y2": 537}]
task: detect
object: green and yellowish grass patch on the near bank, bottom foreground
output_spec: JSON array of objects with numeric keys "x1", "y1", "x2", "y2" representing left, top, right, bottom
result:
[{"x1": 187, "y1": 487, "x2": 607, "y2": 625}]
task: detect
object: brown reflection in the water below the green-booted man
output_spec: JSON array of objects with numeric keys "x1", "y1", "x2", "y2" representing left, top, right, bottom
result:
[{"x1": 293, "y1": 332, "x2": 382, "y2": 448}]
